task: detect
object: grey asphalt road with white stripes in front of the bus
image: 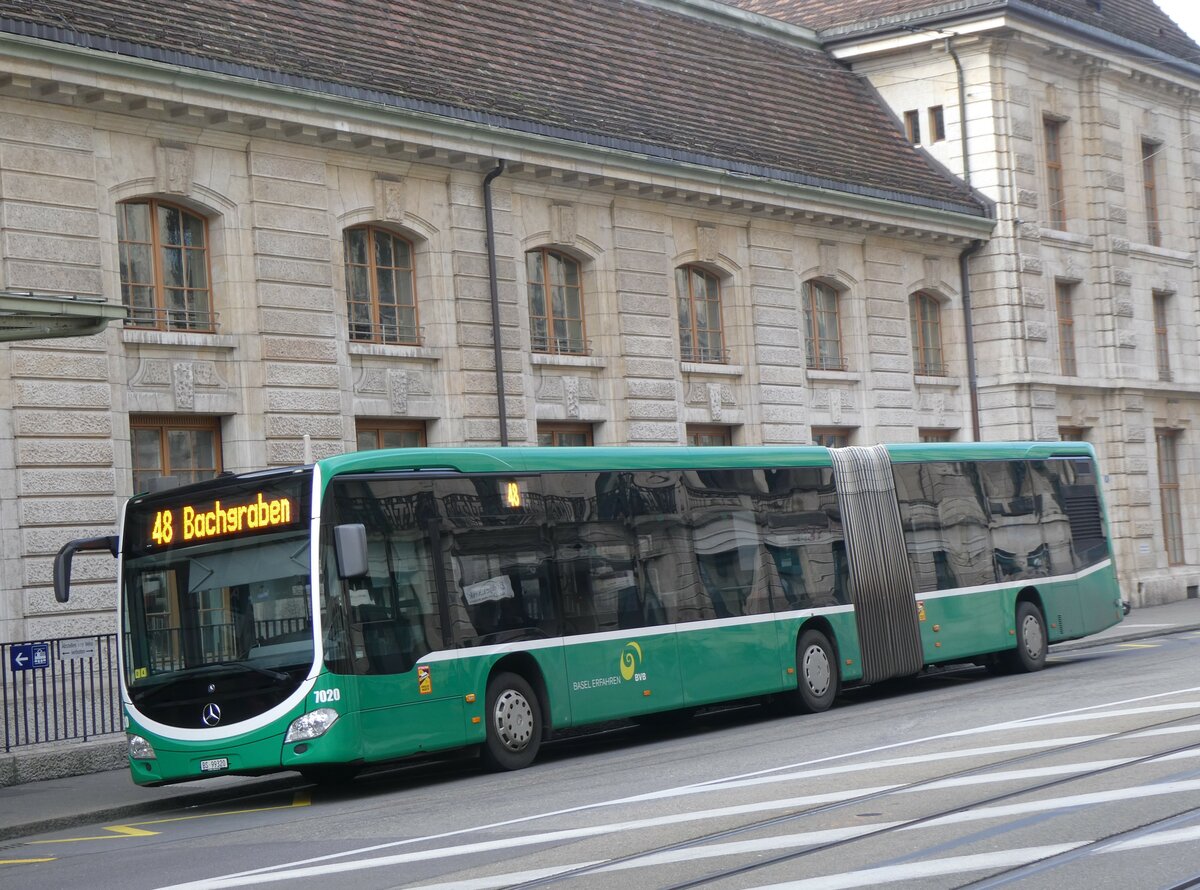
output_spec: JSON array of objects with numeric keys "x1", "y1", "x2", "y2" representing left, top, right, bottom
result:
[{"x1": 9, "y1": 632, "x2": 1200, "y2": 890}]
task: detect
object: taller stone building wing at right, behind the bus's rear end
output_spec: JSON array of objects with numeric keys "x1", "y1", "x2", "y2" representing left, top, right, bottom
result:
[{"x1": 733, "y1": 0, "x2": 1200, "y2": 605}]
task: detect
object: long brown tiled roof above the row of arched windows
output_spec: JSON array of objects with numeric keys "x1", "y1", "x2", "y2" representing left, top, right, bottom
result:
[{"x1": 0, "y1": 0, "x2": 984, "y2": 215}]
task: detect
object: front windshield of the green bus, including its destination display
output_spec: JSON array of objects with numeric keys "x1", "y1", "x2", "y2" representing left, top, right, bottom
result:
[{"x1": 121, "y1": 470, "x2": 316, "y2": 726}]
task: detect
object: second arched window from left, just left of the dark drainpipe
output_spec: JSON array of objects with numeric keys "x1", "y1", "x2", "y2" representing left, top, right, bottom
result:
[{"x1": 344, "y1": 225, "x2": 421, "y2": 345}]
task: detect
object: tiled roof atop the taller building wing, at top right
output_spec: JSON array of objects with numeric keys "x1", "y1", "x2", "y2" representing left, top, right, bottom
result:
[{"x1": 722, "y1": 0, "x2": 1200, "y2": 64}]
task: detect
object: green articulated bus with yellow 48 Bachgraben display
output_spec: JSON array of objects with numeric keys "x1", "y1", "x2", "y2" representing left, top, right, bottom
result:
[{"x1": 54, "y1": 443, "x2": 1122, "y2": 784}]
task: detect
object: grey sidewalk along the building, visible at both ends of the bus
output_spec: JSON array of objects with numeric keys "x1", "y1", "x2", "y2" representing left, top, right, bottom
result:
[{"x1": 0, "y1": 600, "x2": 1200, "y2": 841}]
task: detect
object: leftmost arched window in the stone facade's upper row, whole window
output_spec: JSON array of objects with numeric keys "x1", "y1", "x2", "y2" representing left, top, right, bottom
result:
[{"x1": 116, "y1": 198, "x2": 216, "y2": 331}]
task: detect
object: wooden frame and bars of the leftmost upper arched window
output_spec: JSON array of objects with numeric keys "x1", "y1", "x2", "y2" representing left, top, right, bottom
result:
[{"x1": 116, "y1": 198, "x2": 217, "y2": 333}]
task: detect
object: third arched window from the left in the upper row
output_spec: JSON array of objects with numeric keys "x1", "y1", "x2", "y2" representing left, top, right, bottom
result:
[{"x1": 526, "y1": 247, "x2": 588, "y2": 355}]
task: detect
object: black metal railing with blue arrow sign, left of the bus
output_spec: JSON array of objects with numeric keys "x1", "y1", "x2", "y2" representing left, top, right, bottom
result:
[{"x1": 0, "y1": 633, "x2": 124, "y2": 752}]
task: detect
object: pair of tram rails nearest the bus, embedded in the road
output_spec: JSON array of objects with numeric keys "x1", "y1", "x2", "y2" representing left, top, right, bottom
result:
[{"x1": 511, "y1": 711, "x2": 1200, "y2": 890}]
